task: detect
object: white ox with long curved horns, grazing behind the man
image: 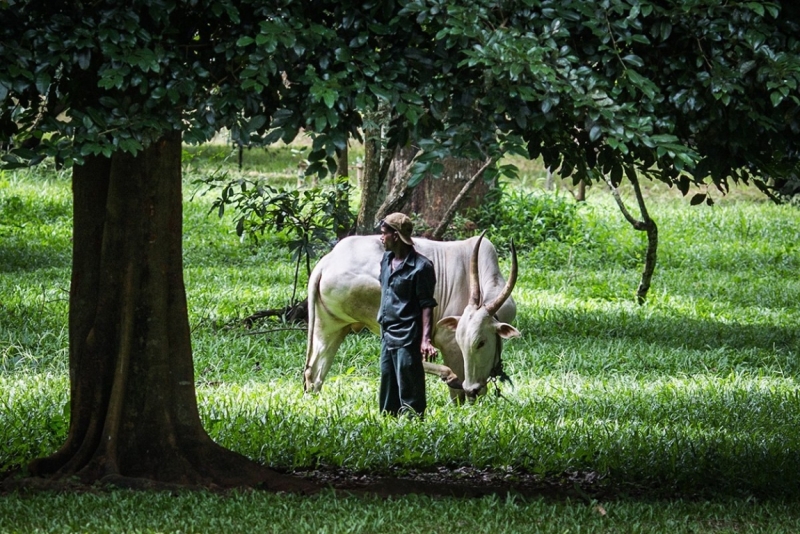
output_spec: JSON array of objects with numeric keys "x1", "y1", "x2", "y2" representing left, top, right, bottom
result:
[{"x1": 304, "y1": 235, "x2": 519, "y2": 400}]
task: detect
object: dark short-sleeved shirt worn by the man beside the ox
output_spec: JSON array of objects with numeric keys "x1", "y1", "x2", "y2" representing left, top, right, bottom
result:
[{"x1": 378, "y1": 249, "x2": 436, "y2": 348}]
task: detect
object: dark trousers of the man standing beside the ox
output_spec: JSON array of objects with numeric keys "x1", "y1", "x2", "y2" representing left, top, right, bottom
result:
[{"x1": 380, "y1": 343, "x2": 427, "y2": 416}]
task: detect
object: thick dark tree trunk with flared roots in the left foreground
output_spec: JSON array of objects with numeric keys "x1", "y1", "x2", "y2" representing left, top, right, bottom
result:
[{"x1": 25, "y1": 132, "x2": 308, "y2": 490}]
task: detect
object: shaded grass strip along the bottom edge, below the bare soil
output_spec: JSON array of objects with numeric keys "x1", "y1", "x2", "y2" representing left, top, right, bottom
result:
[{"x1": 0, "y1": 491, "x2": 800, "y2": 534}]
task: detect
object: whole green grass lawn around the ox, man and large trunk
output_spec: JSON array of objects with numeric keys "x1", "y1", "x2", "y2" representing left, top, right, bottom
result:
[{"x1": 0, "y1": 147, "x2": 800, "y2": 532}]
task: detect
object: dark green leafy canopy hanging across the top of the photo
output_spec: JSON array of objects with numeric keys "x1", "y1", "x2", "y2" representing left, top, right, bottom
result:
[{"x1": 0, "y1": 0, "x2": 800, "y2": 194}]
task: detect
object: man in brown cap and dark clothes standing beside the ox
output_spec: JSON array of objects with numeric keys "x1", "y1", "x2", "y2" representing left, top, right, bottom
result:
[{"x1": 378, "y1": 213, "x2": 436, "y2": 417}]
